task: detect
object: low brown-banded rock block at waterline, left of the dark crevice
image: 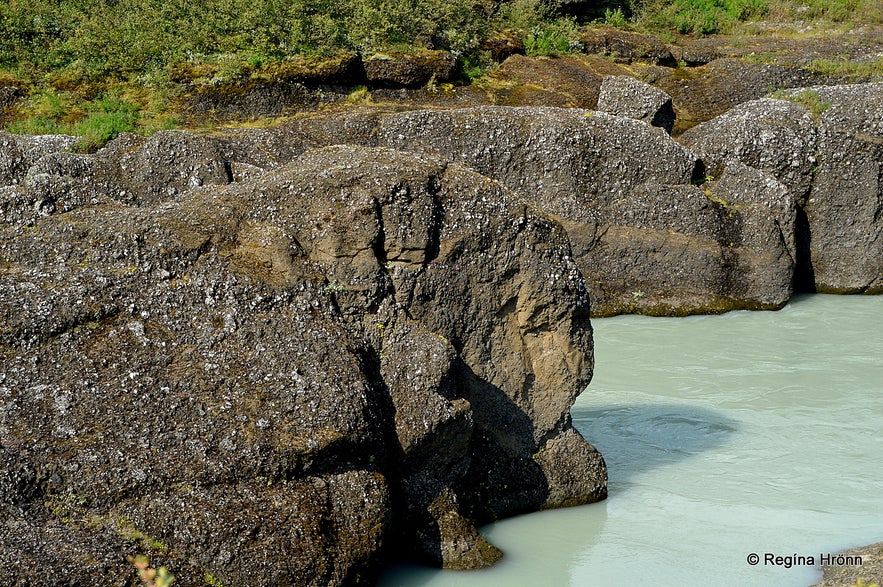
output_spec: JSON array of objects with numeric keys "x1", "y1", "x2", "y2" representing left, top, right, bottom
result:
[{"x1": 584, "y1": 166, "x2": 795, "y2": 315}]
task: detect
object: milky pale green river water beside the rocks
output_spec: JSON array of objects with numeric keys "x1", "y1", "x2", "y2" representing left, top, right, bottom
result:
[{"x1": 381, "y1": 296, "x2": 883, "y2": 587}]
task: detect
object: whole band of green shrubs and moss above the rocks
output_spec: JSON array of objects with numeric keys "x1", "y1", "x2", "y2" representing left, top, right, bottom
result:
[{"x1": 0, "y1": 0, "x2": 883, "y2": 146}]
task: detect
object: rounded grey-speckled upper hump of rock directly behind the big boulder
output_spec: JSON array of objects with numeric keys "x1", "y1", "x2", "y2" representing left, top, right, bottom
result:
[{"x1": 377, "y1": 107, "x2": 697, "y2": 221}]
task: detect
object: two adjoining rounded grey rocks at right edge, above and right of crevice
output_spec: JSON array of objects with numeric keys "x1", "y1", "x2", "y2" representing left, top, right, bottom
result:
[{"x1": 681, "y1": 83, "x2": 883, "y2": 293}]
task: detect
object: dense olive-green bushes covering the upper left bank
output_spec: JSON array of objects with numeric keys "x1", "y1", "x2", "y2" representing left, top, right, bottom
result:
[{"x1": 0, "y1": 0, "x2": 494, "y2": 78}]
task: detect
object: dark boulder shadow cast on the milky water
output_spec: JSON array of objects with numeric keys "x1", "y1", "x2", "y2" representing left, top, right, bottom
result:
[{"x1": 571, "y1": 403, "x2": 739, "y2": 486}]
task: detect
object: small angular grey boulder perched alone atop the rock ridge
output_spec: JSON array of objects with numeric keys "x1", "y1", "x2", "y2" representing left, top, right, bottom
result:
[{"x1": 598, "y1": 75, "x2": 675, "y2": 134}]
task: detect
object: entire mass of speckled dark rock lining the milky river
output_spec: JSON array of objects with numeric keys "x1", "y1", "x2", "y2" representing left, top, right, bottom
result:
[{"x1": 0, "y1": 84, "x2": 883, "y2": 585}]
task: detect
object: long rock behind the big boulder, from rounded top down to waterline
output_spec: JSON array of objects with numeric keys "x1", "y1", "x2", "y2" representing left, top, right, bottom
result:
[{"x1": 360, "y1": 108, "x2": 808, "y2": 316}]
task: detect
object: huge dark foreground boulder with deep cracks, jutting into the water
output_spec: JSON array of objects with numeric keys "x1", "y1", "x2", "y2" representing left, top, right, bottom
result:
[{"x1": 0, "y1": 140, "x2": 606, "y2": 585}]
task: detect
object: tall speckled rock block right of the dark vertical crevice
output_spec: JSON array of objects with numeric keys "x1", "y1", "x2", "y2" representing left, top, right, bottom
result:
[{"x1": 805, "y1": 83, "x2": 883, "y2": 293}]
